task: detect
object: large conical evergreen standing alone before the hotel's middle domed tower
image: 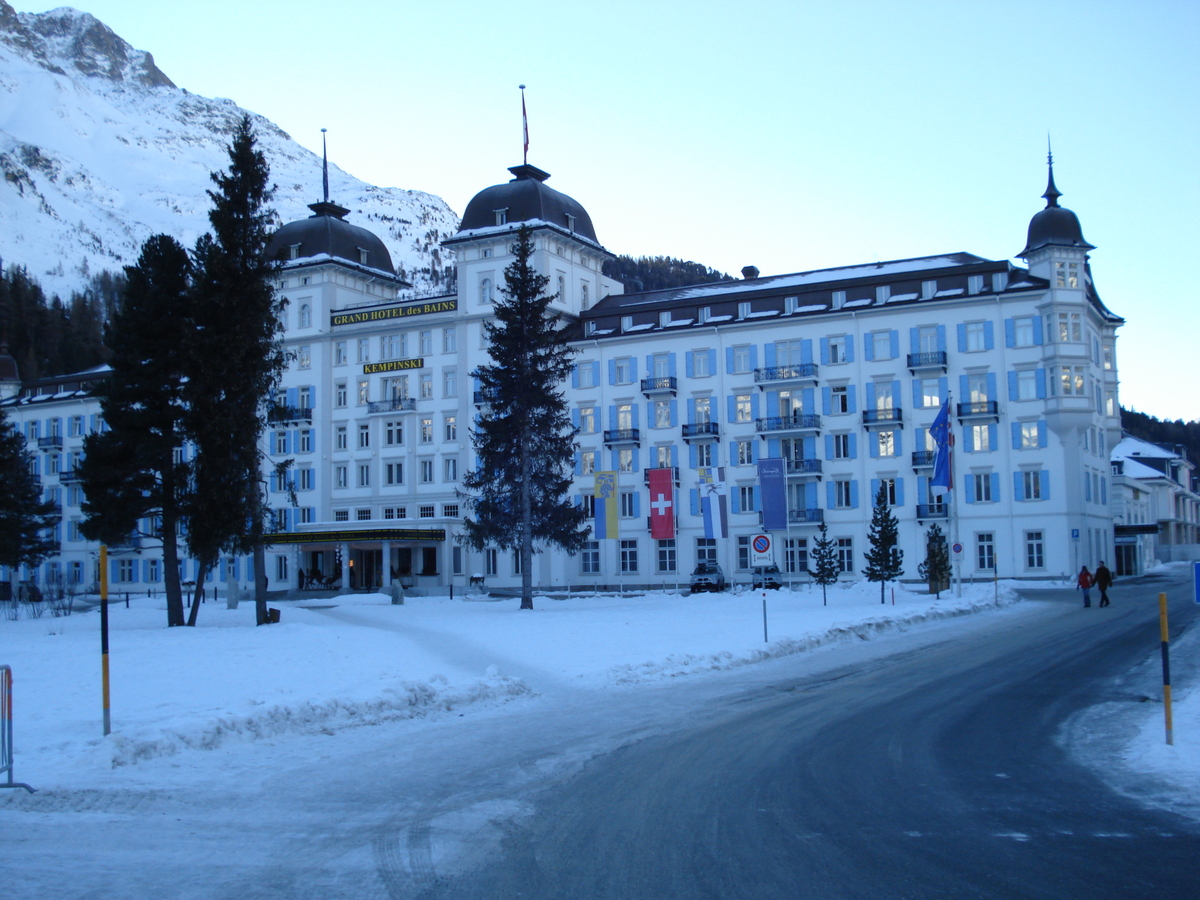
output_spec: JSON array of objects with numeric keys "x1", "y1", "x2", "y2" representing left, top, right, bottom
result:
[{"x1": 463, "y1": 226, "x2": 588, "y2": 610}]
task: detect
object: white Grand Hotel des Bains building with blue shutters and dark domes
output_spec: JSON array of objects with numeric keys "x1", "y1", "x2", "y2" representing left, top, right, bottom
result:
[{"x1": 0, "y1": 160, "x2": 1123, "y2": 600}]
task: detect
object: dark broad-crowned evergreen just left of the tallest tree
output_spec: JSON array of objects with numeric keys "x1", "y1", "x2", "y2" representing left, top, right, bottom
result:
[{"x1": 79, "y1": 234, "x2": 192, "y2": 625}]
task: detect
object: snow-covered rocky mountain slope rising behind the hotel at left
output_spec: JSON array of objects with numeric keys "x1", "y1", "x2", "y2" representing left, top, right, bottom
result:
[{"x1": 0, "y1": 0, "x2": 458, "y2": 298}]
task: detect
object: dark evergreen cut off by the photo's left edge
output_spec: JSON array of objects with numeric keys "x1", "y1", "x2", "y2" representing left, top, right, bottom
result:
[{"x1": 0, "y1": 409, "x2": 60, "y2": 596}]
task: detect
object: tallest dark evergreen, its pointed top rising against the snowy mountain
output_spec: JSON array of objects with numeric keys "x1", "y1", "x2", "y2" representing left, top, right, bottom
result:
[{"x1": 185, "y1": 115, "x2": 284, "y2": 624}]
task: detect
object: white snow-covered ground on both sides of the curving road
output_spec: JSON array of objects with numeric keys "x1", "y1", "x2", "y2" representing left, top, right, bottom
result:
[{"x1": 0, "y1": 582, "x2": 1200, "y2": 816}]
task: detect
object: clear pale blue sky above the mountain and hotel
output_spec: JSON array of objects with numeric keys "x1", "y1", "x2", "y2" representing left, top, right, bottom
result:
[{"x1": 25, "y1": 0, "x2": 1200, "y2": 419}]
